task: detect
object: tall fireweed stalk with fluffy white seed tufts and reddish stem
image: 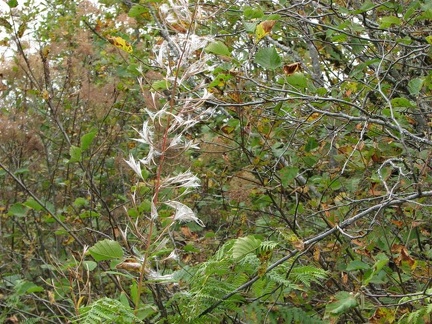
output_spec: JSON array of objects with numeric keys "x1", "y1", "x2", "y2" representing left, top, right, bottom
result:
[{"x1": 119, "y1": 0, "x2": 212, "y2": 315}]
